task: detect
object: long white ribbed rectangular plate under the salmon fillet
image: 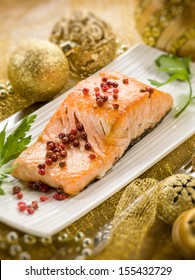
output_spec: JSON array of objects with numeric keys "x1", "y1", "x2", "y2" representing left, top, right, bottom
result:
[{"x1": 0, "y1": 45, "x2": 195, "y2": 236}]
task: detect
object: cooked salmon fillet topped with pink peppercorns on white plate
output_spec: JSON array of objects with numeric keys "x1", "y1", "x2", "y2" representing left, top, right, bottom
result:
[{"x1": 12, "y1": 71, "x2": 173, "y2": 195}]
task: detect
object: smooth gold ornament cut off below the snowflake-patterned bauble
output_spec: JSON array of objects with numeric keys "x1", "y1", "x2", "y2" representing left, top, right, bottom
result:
[{"x1": 172, "y1": 208, "x2": 195, "y2": 260}]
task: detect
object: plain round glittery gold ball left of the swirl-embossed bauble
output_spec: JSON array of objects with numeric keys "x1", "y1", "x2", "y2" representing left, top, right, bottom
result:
[{"x1": 8, "y1": 40, "x2": 69, "y2": 102}]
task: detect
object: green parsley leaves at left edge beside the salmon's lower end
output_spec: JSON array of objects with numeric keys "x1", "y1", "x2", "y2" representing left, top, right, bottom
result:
[{"x1": 0, "y1": 115, "x2": 36, "y2": 194}]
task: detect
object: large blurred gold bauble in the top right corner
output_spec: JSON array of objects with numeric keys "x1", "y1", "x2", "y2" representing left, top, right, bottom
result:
[{"x1": 135, "y1": 0, "x2": 195, "y2": 60}]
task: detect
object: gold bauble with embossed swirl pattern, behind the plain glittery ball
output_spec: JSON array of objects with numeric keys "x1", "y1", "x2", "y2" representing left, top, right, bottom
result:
[{"x1": 50, "y1": 12, "x2": 116, "y2": 76}]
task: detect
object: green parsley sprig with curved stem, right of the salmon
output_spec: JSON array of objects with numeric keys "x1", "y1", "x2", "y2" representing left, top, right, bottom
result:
[{"x1": 148, "y1": 54, "x2": 195, "y2": 118}]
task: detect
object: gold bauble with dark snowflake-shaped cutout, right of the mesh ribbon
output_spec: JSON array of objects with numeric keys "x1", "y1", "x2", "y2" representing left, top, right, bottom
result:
[{"x1": 157, "y1": 174, "x2": 195, "y2": 225}]
